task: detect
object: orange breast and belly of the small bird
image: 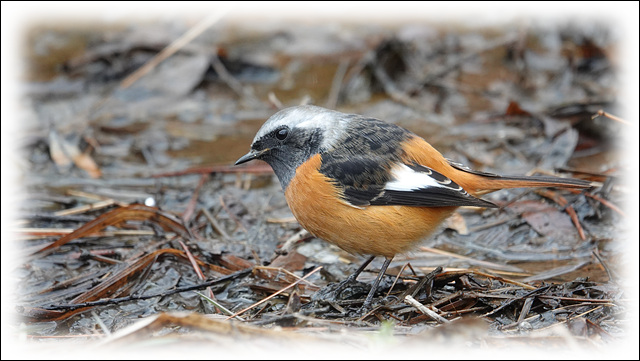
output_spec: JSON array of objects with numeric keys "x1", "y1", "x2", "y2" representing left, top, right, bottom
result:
[{"x1": 285, "y1": 154, "x2": 456, "y2": 257}]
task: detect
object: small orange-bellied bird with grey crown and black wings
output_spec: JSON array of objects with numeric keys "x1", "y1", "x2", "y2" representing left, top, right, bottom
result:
[{"x1": 235, "y1": 105, "x2": 591, "y2": 309}]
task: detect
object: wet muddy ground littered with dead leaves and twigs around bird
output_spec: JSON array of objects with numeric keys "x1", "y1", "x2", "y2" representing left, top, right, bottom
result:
[{"x1": 2, "y1": 7, "x2": 637, "y2": 358}]
